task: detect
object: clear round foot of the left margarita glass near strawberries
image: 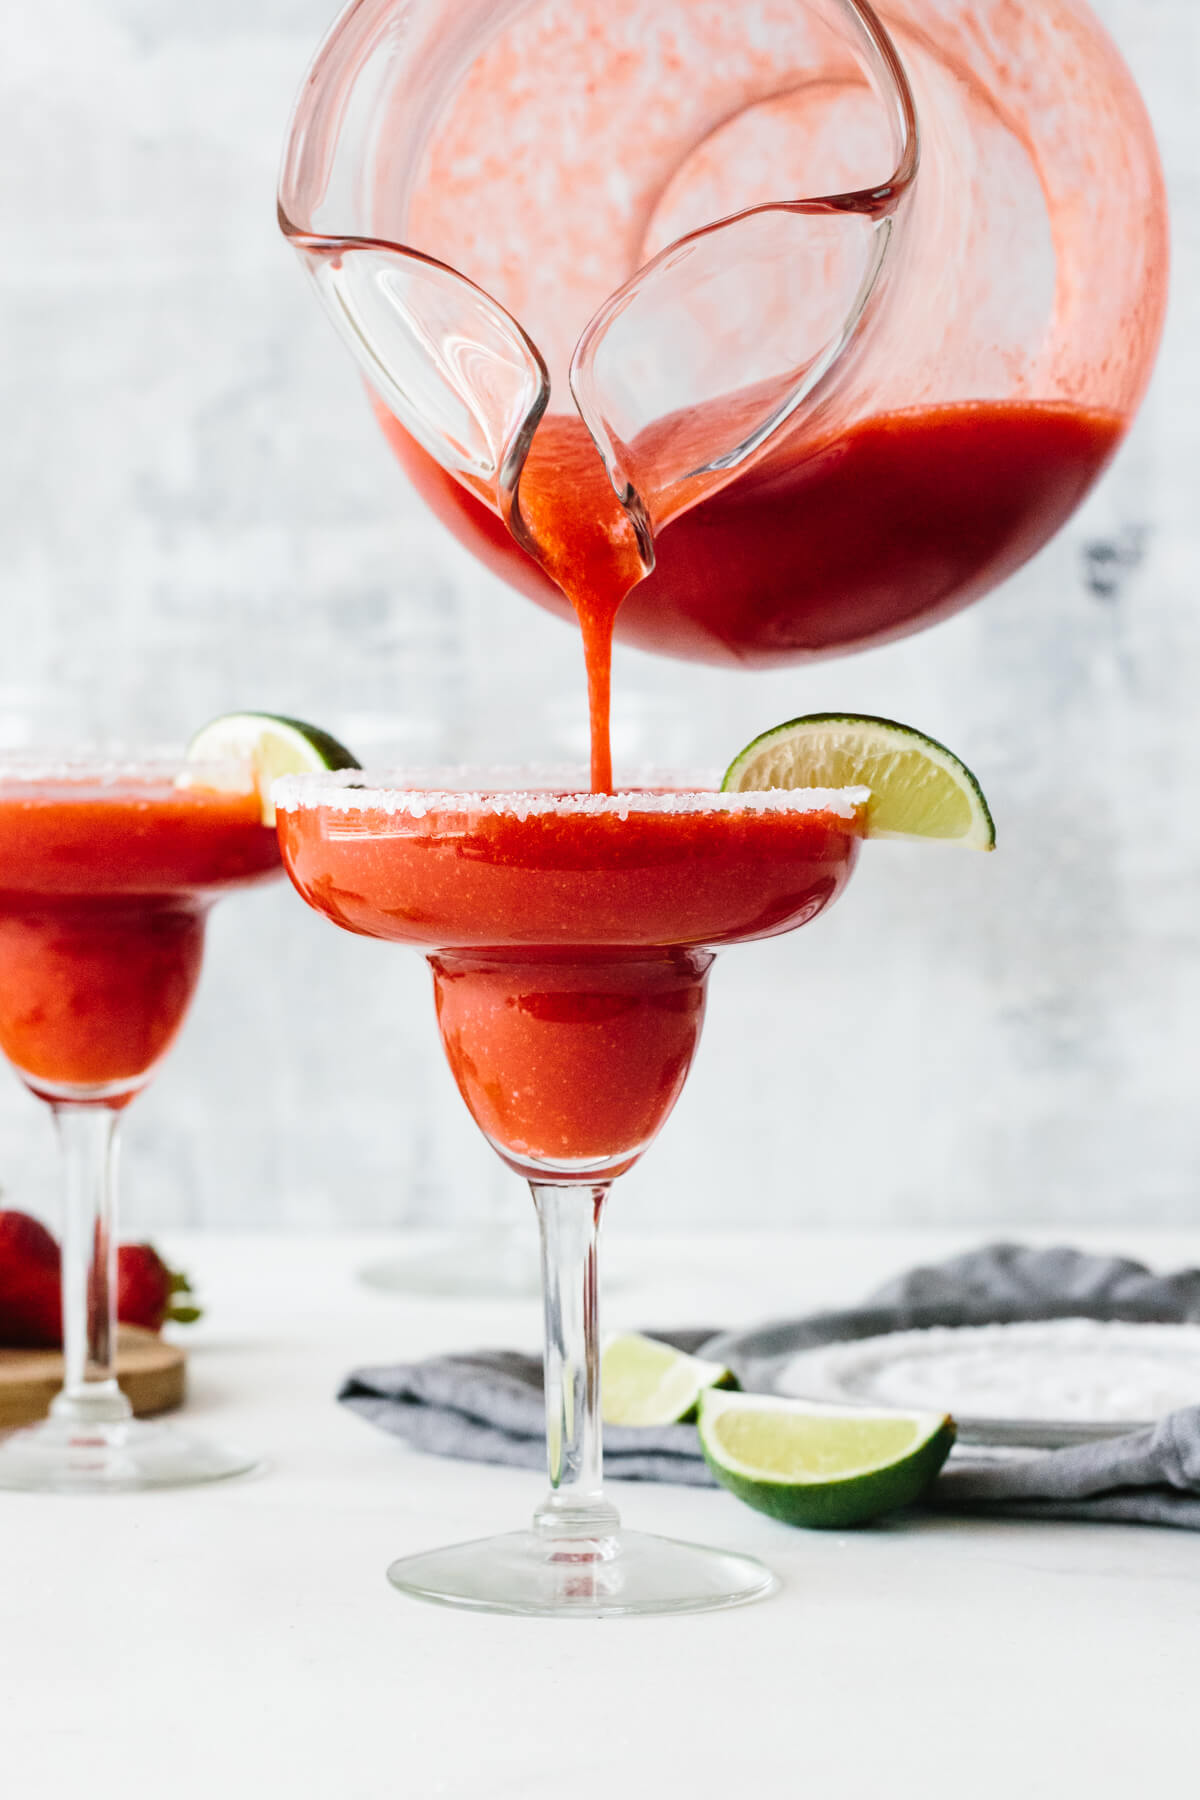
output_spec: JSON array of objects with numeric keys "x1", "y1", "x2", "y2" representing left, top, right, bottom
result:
[{"x1": 0, "y1": 1417, "x2": 259, "y2": 1494}]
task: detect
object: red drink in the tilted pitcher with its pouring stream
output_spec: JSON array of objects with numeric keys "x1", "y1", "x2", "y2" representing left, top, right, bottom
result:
[{"x1": 385, "y1": 400, "x2": 1126, "y2": 787}]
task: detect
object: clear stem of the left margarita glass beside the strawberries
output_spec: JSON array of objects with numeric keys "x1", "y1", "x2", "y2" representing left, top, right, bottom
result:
[{"x1": 50, "y1": 1102, "x2": 131, "y2": 1426}]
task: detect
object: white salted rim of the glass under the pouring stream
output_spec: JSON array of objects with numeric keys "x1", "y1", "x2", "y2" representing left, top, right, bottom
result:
[{"x1": 272, "y1": 767, "x2": 871, "y2": 819}]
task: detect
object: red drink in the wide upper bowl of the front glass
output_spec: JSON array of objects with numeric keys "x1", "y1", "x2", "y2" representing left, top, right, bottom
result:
[{"x1": 279, "y1": 796, "x2": 862, "y2": 958}]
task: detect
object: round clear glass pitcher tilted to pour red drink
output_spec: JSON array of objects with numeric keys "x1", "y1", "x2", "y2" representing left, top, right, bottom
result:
[{"x1": 279, "y1": 0, "x2": 1166, "y2": 669}]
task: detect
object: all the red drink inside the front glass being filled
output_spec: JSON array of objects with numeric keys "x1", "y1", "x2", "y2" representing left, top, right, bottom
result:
[{"x1": 279, "y1": 796, "x2": 860, "y2": 1181}]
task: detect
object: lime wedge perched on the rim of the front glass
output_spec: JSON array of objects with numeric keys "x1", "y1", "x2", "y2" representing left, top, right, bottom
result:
[{"x1": 721, "y1": 713, "x2": 997, "y2": 850}]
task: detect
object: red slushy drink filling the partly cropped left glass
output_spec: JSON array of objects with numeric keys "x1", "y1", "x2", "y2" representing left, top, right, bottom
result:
[{"x1": 0, "y1": 778, "x2": 279, "y2": 1105}]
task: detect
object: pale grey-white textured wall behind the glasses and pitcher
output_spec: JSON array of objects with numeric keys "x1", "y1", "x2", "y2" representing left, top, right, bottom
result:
[{"x1": 0, "y1": 0, "x2": 1200, "y2": 1226}]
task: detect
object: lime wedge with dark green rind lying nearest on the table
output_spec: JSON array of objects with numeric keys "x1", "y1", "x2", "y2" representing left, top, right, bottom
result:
[{"x1": 700, "y1": 1393, "x2": 954, "y2": 1530}]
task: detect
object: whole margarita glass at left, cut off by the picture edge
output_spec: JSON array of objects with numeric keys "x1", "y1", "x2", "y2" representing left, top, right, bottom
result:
[{"x1": 0, "y1": 754, "x2": 279, "y2": 1490}]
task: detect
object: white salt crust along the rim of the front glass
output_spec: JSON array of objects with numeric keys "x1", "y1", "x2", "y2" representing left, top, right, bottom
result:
[{"x1": 272, "y1": 769, "x2": 871, "y2": 821}]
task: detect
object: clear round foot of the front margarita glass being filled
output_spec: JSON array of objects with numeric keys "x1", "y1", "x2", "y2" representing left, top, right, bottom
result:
[{"x1": 387, "y1": 1530, "x2": 779, "y2": 1618}]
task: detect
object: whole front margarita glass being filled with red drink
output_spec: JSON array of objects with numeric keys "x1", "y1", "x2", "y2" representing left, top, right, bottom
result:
[{"x1": 272, "y1": 770, "x2": 867, "y2": 1616}]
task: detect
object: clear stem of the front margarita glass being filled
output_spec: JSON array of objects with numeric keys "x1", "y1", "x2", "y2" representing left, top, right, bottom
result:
[{"x1": 529, "y1": 1181, "x2": 621, "y2": 1557}]
